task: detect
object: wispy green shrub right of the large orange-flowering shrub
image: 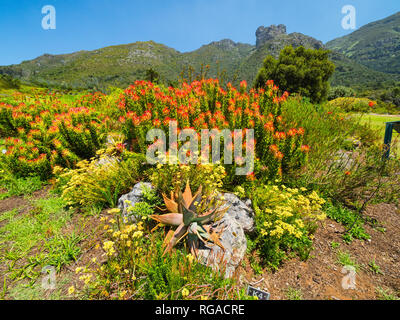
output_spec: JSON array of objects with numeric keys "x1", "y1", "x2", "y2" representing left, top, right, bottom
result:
[{"x1": 282, "y1": 97, "x2": 399, "y2": 205}]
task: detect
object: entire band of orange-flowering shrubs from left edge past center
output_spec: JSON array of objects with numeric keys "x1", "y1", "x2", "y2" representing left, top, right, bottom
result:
[{"x1": 0, "y1": 79, "x2": 309, "y2": 180}]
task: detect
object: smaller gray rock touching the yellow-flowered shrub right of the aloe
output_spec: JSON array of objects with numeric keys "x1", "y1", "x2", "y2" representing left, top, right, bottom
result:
[{"x1": 223, "y1": 193, "x2": 254, "y2": 233}]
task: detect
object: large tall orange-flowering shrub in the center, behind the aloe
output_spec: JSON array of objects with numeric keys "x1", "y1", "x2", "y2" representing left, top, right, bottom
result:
[{"x1": 118, "y1": 79, "x2": 309, "y2": 179}]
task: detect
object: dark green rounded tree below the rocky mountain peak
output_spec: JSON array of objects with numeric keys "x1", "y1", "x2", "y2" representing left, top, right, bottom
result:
[{"x1": 254, "y1": 46, "x2": 335, "y2": 103}]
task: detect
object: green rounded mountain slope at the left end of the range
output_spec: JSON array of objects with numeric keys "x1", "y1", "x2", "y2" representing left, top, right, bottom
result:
[{"x1": 0, "y1": 41, "x2": 181, "y2": 88}]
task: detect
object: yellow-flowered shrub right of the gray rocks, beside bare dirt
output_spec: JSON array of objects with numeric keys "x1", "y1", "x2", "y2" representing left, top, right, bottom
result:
[{"x1": 253, "y1": 185, "x2": 326, "y2": 269}]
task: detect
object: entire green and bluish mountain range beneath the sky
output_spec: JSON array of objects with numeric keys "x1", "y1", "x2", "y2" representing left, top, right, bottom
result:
[{"x1": 0, "y1": 12, "x2": 400, "y2": 89}]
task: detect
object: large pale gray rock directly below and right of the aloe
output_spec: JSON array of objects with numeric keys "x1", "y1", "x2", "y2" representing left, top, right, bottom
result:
[{"x1": 197, "y1": 214, "x2": 247, "y2": 278}]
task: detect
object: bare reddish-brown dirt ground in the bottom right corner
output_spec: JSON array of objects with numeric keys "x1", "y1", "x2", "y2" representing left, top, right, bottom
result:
[{"x1": 239, "y1": 204, "x2": 400, "y2": 300}]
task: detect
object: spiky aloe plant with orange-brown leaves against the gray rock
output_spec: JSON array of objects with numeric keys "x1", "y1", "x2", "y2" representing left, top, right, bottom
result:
[{"x1": 150, "y1": 181, "x2": 228, "y2": 256}]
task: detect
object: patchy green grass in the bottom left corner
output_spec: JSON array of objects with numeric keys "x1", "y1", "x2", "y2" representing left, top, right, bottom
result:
[{"x1": 0, "y1": 196, "x2": 84, "y2": 300}]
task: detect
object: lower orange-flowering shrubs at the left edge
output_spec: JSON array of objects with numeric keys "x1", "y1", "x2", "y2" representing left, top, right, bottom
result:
[{"x1": 0, "y1": 93, "x2": 108, "y2": 179}]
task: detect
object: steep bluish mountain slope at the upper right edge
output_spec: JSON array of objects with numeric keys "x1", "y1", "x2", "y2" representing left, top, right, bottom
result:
[{"x1": 326, "y1": 12, "x2": 400, "y2": 74}]
